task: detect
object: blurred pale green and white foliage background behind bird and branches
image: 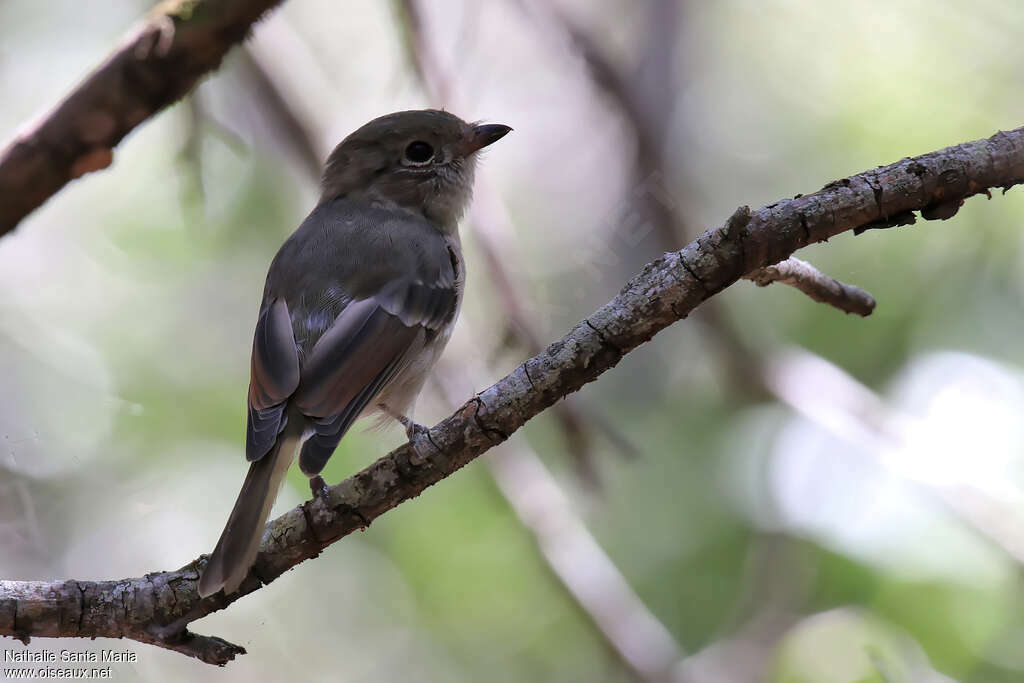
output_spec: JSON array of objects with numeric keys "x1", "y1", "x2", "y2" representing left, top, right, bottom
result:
[{"x1": 0, "y1": 0, "x2": 1024, "y2": 683}]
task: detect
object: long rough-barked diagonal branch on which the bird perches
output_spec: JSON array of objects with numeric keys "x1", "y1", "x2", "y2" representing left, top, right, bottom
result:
[{"x1": 0, "y1": 128, "x2": 1024, "y2": 664}]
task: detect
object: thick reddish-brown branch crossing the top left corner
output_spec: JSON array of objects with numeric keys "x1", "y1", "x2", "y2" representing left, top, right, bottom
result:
[{"x1": 0, "y1": 0, "x2": 282, "y2": 236}]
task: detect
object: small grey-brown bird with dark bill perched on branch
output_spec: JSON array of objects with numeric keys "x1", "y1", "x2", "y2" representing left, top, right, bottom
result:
[{"x1": 199, "y1": 110, "x2": 511, "y2": 597}]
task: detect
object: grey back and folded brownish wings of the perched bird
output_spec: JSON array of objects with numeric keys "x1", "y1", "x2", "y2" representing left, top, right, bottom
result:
[{"x1": 246, "y1": 201, "x2": 457, "y2": 475}]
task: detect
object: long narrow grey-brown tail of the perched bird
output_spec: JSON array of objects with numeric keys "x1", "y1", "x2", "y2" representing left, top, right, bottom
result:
[{"x1": 199, "y1": 416, "x2": 303, "y2": 598}]
